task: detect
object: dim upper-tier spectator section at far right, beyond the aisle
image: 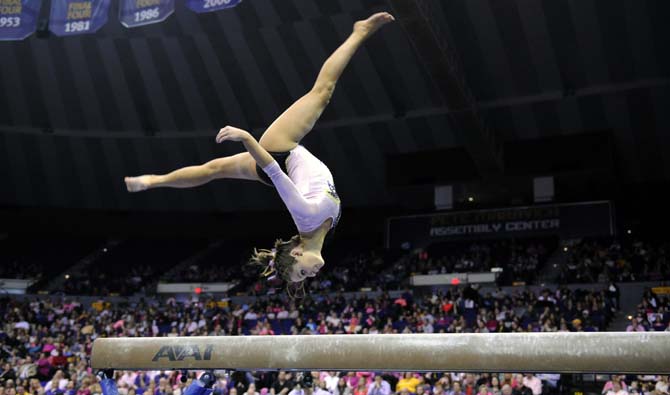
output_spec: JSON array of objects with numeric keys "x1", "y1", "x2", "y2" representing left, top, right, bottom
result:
[{"x1": 560, "y1": 239, "x2": 670, "y2": 283}]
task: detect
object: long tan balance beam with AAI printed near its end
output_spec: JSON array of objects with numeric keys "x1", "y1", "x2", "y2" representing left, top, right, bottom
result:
[{"x1": 91, "y1": 332, "x2": 670, "y2": 374}]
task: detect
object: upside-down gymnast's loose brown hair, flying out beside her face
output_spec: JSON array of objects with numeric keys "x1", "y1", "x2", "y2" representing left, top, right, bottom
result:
[{"x1": 249, "y1": 235, "x2": 305, "y2": 299}]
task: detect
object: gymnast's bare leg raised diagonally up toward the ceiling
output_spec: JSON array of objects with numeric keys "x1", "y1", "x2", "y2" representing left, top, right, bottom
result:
[{"x1": 259, "y1": 12, "x2": 394, "y2": 152}]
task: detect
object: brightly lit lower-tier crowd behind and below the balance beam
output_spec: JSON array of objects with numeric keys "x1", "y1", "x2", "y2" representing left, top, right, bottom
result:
[{"x1": 0, "y1": 286, "x2": 668, "y2": 395}]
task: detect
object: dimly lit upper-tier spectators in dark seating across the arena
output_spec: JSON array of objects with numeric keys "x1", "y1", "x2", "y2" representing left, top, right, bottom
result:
[{"x1": 0, "y1": 234, "x2": 670, "y2": 296}]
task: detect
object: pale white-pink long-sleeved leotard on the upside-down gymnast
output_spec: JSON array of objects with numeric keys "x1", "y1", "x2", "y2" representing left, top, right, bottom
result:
[{"x1": 263, "y1": 145, "x2": 340, "y2": 233}]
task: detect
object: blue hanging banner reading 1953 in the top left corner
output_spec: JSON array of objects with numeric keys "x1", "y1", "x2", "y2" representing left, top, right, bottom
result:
[{"x1": 0, "y1": 0, "x2": 41, "y2": 41}]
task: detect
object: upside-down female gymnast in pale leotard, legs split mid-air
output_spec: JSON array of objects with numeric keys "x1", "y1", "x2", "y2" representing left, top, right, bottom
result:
[{"x1": 125, "y1": 12, "x2": 394, "y2": 290}]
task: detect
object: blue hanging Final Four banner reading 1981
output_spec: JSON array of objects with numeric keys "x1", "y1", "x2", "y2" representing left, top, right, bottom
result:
[{"x1": 49, "y1": 0, "x2": 110, "y2": 36}]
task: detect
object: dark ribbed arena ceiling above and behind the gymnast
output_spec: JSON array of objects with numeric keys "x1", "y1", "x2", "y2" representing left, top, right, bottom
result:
[{"x1": 0, "y1": 0, "x2": 670, "y2": 211}]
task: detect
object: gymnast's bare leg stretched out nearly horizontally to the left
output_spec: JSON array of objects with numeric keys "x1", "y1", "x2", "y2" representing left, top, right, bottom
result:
[{"x1": 125, "y1": 152, "x2": 260, "y2": 192}]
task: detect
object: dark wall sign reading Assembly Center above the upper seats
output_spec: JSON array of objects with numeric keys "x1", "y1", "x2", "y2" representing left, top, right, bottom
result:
[{"x1": 386, "y1": 201, "x2": 614, "y2": 248}]
